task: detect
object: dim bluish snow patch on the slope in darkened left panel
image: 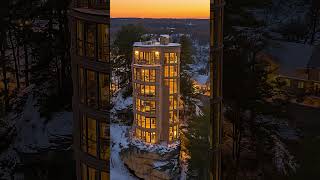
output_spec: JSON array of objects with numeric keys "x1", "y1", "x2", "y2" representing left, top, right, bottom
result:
[{"x1": 14, "y1": 93, "x2": 72, "y2": 153}]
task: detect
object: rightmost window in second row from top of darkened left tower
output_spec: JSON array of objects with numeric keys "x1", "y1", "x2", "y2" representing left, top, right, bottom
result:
[{"x1": 99, "y1": 73, "x2": 110, "y2": 110}]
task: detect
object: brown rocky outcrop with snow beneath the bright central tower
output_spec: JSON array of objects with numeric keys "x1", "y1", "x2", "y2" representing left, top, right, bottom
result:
[{"x1": 120, "y1": 145, "x2": 180, "y2": 180}]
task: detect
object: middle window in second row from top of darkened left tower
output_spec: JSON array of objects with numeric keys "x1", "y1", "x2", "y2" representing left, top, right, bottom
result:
[{"x1": 87, "y1": 70, "x2": 97, "y2": 107}]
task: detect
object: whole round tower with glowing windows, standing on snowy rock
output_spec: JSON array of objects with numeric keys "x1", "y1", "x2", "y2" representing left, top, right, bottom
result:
[{"x1": 132, "y1": 35, "x2": 180, "y2": 144}]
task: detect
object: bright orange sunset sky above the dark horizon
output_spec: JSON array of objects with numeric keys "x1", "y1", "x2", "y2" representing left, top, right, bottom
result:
[{"x1": 110, "y1": 0, "x2": 210, "y2": 19}]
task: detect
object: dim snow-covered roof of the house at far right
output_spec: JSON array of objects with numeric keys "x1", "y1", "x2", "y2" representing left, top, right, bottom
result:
[{"x1": 265, "y1": 41, "x2": 314, "y2": 76}]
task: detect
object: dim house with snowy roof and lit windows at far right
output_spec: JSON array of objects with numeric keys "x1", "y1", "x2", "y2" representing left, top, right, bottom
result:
[{"x1": 258, "y1": 41, "x2": 320, "y2": 107}]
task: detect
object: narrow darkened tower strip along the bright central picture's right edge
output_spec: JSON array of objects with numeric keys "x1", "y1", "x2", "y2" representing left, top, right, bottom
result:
[{"x1": 209, "y1": 0, "x2": 225, "y2": 180}]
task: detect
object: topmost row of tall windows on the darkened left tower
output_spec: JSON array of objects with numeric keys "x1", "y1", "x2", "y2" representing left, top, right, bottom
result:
[{"x1": 76, "y1": 20, "x2": 109, "y2": 62}]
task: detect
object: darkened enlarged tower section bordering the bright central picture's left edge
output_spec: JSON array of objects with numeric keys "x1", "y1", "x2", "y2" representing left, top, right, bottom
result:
[{"x1": 69, "y1": 0, "x2": 111, "y2": 180}]
